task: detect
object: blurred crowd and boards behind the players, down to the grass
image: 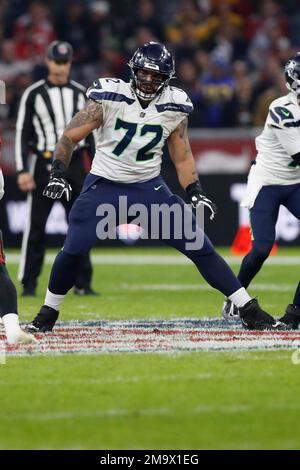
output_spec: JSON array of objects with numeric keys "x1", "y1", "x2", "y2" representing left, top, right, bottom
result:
[{"x1": 0, "y1": 0, "x2": 300, "y2": 250}]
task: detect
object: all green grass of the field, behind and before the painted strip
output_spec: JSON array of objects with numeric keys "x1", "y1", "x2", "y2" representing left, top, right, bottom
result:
[{"x1": 0, "y1": 248, "x2": 300, "y2": 449}]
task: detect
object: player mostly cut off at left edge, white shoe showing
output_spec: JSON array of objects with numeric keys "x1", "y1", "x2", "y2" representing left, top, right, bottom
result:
[{"x1": 0, "y1": 168, "x2": 36, "y2": 344}]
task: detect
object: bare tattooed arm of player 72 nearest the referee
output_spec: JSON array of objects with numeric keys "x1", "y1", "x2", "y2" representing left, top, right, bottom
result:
[{"x1": 54, "y1": 100, "x2": 103, "y2": 167}]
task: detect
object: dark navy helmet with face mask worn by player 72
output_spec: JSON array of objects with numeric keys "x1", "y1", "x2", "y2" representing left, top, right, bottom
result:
[{"x1": 128, "y1": 42, "x2": 175, "y2": 101}]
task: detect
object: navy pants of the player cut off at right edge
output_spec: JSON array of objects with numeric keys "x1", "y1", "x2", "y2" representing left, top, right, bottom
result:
[{"x1": 238, "y1": 184, "x2": 300, "y2": 287}]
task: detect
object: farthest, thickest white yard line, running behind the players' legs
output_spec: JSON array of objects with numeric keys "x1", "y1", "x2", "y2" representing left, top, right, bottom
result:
[{"x1": 7, "y1": 253, "x2": 300, "y2": 266}]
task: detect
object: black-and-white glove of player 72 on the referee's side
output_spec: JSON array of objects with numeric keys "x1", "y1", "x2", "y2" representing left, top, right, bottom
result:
[{"x1": 43, "y1": 160, "x2": 72, "y2": 202}]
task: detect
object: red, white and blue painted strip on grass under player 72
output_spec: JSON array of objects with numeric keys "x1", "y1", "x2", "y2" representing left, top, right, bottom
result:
[{"x1": 6, "y1": 318, "x2": 300, "y2": 360}]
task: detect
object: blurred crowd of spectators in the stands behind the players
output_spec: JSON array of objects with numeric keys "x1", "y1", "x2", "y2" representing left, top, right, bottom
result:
[{"x1": 0, "y1": 0, "x2": 300, "y2": 128}]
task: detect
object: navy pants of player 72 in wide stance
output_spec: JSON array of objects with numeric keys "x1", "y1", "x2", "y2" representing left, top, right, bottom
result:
[{"x1": 49, "y1": 174, "x2": 241, "y2": 295}]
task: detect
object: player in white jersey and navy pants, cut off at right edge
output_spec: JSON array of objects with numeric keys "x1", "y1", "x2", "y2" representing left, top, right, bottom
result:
[{"x1": 223, "y1": 53, "x2": 300, "y2": 329}]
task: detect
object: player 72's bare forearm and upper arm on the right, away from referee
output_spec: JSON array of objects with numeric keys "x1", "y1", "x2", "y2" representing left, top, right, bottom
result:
[{"x1": 168, "y1": 118, "x2": 198, "y2": 189}]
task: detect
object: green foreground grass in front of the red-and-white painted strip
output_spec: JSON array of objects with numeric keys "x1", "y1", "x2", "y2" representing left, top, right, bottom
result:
[{"x1": 0, "y1": 351, "x2": 300, "y2": 449}]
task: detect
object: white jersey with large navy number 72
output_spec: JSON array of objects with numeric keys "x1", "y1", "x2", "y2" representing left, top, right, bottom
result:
[{"x1": 87, "y1": 78, "x2": 193, "y2": 183}]
